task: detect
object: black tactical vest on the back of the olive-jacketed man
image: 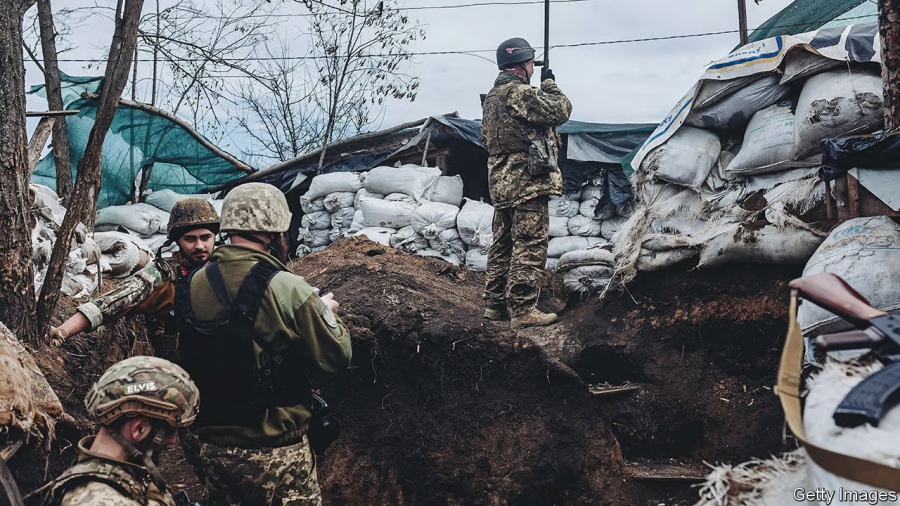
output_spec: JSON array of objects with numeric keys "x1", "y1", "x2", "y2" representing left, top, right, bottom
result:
[{"x1": 175, "y1": 262, "x2": 312, "y2": 428}]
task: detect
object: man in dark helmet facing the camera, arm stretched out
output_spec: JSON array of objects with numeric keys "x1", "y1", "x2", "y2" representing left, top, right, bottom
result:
[{"x1": 50, "y1": 198, "x2": 219, "y2": 359}]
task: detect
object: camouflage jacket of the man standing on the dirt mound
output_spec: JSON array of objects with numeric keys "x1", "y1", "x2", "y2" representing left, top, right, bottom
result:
[{"x1": 481, "y1": 71, "x2": 572, "y2": 209}]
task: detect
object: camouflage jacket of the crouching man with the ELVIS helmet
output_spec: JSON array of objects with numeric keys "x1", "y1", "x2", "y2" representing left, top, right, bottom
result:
[{"x1": 45, "y1": 436, "x2": 175, "y2": 506}]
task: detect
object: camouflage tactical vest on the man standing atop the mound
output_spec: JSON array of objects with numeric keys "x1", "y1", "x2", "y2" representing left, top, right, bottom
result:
[{"x1": 481, "y1": 82, "x2": 540, "y2": 156}]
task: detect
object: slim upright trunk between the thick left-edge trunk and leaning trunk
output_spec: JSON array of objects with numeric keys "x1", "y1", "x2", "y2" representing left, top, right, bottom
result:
[{"x1": 38, "y1": 0, "x2": 72, "y2": 205}]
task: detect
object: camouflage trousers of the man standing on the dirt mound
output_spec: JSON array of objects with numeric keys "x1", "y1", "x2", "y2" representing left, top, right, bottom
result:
[{"x1": 484, "y1": 195, "x2": 550, "y2": 316}]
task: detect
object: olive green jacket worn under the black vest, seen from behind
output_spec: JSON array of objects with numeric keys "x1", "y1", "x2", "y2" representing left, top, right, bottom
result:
[{"x1": 182, "y1": 245, "x2": 352, "y2": 448}]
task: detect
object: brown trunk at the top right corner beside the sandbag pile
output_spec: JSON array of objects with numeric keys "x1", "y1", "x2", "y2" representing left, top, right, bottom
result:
[{"x1": 878, "y1": 0, "x2": 900, "y2": 130}]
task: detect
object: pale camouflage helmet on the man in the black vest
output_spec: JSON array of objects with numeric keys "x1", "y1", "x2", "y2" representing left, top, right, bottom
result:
[{"x1": 222, "y1": 183, "x2": 291, "y2": 233}]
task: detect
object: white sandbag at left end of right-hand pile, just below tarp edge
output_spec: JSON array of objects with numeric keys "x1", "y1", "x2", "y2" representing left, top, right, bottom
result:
[{"x1": 641, "y1": 126, "x2": 722, "y2": 191}]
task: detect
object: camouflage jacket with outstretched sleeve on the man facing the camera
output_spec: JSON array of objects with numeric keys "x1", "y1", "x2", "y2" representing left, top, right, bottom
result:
[{"x1": 78, "y1": 253, "x2": 189, "y2": 331}]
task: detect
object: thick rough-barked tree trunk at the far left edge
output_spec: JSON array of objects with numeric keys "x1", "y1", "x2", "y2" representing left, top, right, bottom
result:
[{"x1": 0, "y1": 0, "x2": 37, "y2": 342}]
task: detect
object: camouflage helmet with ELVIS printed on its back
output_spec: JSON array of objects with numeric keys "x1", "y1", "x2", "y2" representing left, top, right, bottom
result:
[{"x1": 84, "y1": 356, "x2": 200, "y2": 427}]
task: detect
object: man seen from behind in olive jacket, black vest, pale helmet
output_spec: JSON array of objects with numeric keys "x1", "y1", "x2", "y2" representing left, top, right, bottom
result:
[{"x1": 175, "y1": 183, "x2": 351, "y2": 506}]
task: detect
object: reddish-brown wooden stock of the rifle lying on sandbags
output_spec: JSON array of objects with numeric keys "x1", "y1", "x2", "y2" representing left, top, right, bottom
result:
[{"x1": 790, "y1": 273, "x2": 886, "y2": 327}]
